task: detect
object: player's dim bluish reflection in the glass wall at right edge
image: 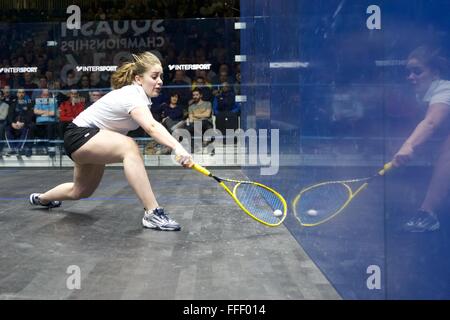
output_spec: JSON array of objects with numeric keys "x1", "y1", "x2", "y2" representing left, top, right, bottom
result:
[{"x1": 392, "y1": 46, "x2": 450, "y2": 232}]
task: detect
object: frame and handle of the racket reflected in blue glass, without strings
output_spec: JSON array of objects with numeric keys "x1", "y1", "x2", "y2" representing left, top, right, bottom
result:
[{"x1": 292, "y1": 162, "x2": 392, "y2": 227}]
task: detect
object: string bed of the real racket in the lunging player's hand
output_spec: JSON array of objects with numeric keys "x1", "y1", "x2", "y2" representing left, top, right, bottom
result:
[{"x1": 235, "y1": 183, "x2": 284, "y2": 224}]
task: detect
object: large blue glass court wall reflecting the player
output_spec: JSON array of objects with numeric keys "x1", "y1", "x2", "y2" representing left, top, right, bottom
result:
[{"x1": 241, "y1": 0, "x2": 450, "y2": 299}]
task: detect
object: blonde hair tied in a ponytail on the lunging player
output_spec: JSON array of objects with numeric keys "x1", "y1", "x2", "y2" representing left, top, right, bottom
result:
[{"x1": 111, "y1": 51, "x2": 161, "y2": 89}]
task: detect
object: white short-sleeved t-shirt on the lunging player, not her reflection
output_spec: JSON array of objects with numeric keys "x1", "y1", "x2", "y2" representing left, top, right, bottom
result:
[{"x1": 73, "y1": 84, "x2": 152, "y2": 134}]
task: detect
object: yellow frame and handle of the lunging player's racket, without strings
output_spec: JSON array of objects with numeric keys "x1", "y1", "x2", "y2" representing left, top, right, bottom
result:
[{"x1": 191, "y1": 164, "x2": 287, "y2": 227}]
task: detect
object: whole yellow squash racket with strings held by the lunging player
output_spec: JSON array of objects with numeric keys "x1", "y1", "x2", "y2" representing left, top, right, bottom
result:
[{"x1": 187, "y1": 164, "x2": 287, "y2": 227}]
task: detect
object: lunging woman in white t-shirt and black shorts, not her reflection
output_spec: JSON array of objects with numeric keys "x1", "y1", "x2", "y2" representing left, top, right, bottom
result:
[{"x1": 30, "y1": 52, "x2": 192, "y2": 231}]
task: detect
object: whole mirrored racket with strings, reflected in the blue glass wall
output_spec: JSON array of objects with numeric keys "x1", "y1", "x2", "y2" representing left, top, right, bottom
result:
[{"x1": 293, "y1": 162, "x2": 392, "y2": 227}]
